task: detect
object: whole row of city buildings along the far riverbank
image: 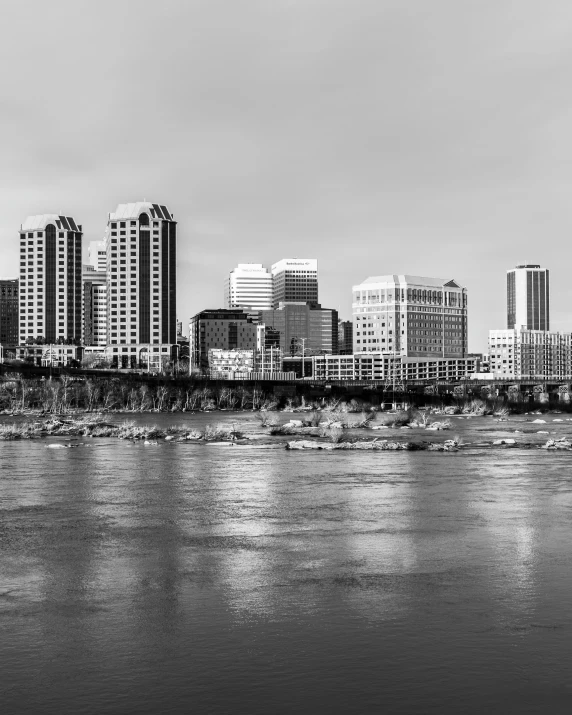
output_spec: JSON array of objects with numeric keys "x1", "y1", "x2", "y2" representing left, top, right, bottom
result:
[{"x1": 11, "y1": 201, "x2": 572, "y2": 377}]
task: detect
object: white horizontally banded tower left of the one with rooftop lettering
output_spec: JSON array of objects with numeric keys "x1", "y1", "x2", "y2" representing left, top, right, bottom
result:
[{"x1": 224, "y1": 263, "x2": 272, "y2": 314}]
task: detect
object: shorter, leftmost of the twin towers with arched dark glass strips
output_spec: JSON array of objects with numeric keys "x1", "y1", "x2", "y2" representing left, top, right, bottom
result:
[{"x1": 19, "y1": 214, "x2": 83, "y2": 344}]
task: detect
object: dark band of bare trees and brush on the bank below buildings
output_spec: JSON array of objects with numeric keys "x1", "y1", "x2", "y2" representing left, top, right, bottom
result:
[{"x1": 0, "y1": 373, "x2": 572, "y2": 421}]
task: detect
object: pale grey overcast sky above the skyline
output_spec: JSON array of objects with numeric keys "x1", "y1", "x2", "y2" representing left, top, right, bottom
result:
[{"x1": 0, "y1": 0, "x2": 572, "y2": 351}]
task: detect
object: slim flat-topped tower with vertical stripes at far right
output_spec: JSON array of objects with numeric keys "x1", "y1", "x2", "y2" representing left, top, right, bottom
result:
[{"x1": 506, "y1": 264, "x2": 550, "y2": 330}]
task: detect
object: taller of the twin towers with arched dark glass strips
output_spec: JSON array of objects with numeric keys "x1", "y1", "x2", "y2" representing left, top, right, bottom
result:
[{"x1": 106, "y1": 201, "x2": 177, "y2": 363}]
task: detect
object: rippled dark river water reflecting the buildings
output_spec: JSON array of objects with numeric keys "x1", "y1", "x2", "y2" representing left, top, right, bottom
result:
[{"x1": 0, "y1": 415, "x2": 572, "y2": 715}]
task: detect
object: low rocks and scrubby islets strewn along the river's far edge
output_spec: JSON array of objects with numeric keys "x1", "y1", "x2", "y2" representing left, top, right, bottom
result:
[{"x1": 0, "y1": 408, "x2": 572, "y2": 452}]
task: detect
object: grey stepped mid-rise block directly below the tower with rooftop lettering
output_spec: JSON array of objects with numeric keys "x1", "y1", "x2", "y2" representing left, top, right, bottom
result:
[{"x1": 260, "y1": 303, "x2": 338, "y2": 357}]
